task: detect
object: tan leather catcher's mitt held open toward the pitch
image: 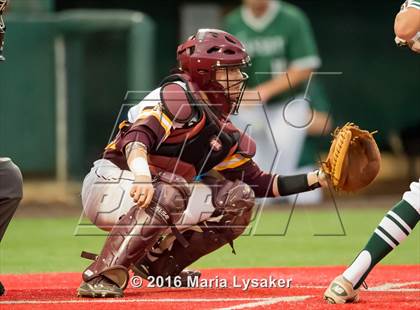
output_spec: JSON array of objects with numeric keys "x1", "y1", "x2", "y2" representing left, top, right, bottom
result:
[{"x1": 321, "y1": 123, "x2": 381, "y2": 192}]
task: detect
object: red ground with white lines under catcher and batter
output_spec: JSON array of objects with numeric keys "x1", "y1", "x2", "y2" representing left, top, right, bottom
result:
[{"x1": 0, "y1": 265, "x2": 420, "y2": 310}]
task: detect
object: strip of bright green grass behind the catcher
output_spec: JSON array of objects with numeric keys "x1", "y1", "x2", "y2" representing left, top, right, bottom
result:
[{"x1": 0, "y1": 207, "x2": 420, "y2": 273}]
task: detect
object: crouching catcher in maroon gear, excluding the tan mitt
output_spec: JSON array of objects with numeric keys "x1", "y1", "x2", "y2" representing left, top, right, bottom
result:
[{"x1": 78, "y1": 29, "x2": 326, "y2": 297}]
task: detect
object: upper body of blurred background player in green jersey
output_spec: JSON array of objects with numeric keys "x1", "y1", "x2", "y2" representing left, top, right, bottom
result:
[{"x1": 225, "y1": 0, "x2": 321, "y2": 105}]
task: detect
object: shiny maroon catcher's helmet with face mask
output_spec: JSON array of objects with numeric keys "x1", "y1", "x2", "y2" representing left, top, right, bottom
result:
[{"x1": 177, "y1": 29, "x2": 250, "y2": 114}]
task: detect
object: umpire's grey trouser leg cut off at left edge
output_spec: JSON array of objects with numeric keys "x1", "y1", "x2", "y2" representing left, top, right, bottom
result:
[{"x1": 0, "y1": 157, "x2": 22, "y2": 242}]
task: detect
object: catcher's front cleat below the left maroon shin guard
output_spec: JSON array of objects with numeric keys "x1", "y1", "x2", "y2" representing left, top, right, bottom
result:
[{"x1": 77, "y1": 276, "x2": 124, "y2": 298}]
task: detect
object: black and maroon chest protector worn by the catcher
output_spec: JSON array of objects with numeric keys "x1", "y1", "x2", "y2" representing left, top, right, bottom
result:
[{"x1": 150, "y1": 75, "x2": 241, "y2": 175}]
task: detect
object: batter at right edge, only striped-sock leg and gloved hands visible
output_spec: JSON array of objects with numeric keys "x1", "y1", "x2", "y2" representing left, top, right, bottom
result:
[{"x1": 324, "y1": 0, "x2": 420, "y2": 304}]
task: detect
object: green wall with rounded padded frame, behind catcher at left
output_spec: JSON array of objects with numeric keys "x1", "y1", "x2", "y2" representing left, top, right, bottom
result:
[{"x1": 0, "y1": 10, "x2": 155, "y2": 178}]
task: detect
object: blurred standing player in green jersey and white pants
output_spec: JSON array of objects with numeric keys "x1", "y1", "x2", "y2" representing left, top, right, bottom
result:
[{"x1": 225, "y1": 0, "x2": 331, "y2": 203}]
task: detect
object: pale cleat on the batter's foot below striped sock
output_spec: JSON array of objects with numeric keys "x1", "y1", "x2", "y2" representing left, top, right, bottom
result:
[{"x1": 324, "y1": 275, "x2": 359, "y2": 304}]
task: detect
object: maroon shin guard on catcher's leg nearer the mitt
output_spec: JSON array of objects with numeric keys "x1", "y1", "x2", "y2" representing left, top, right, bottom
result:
[{"x1": 141, "y1": 180, "x2": 255, "y2": 278}]
